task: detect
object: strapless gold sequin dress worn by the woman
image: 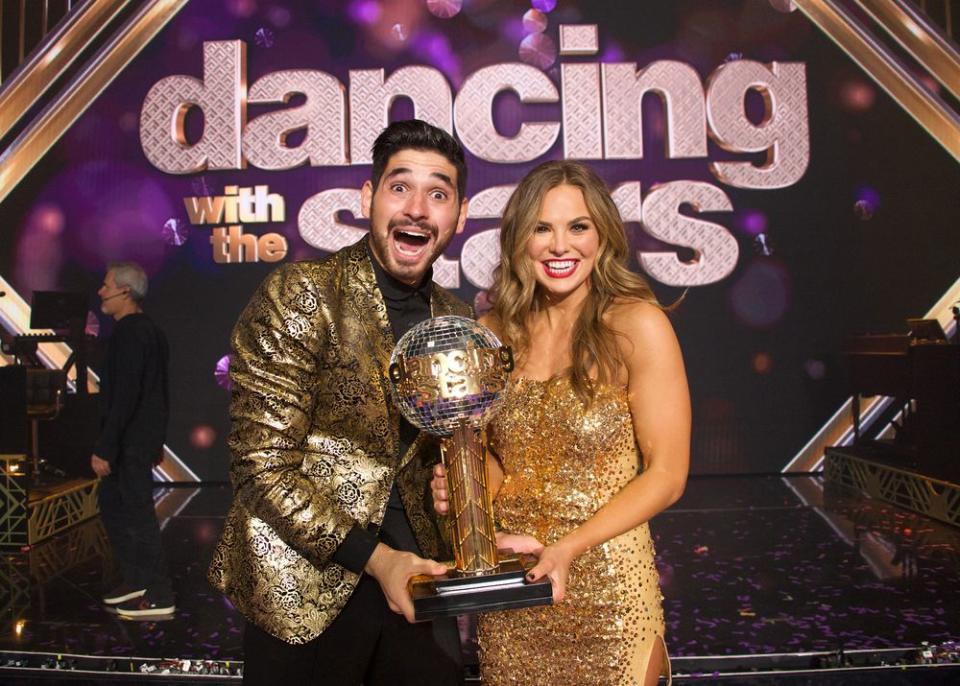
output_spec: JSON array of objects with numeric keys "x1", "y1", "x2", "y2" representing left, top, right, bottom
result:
[{"x1": 479, "y1": 378, "x2": 669, "y2": 686}]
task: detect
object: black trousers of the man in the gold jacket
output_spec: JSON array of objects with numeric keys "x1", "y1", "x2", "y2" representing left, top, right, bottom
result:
[{"x1": 243, "y1": 575, "x2": 463, "y2": 686}]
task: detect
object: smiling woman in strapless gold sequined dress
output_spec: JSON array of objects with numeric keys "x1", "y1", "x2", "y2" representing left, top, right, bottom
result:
[{"x1": 432, "y1": 161, "x2": 690, "y2": 686}]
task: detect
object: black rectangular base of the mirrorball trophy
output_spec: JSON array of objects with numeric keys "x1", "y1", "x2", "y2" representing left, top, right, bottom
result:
[{"x1": 410, "y1": 555, "x2": 553, "y2": 621}]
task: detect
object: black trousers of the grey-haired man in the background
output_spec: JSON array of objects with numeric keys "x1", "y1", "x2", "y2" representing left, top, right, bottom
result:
[{"x1": 99, "y1": 453, "x2": 173, "y2": 602}]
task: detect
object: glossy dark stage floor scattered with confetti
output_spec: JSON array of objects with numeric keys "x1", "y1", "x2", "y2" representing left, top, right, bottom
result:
[{"x1": 0, "y1": 476, "x2": 960, "y2": 660}]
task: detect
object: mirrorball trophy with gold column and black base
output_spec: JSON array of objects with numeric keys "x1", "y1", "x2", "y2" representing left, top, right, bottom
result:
[{"x1": 389, "y1": 316, "x2": 552, "y2": 620}]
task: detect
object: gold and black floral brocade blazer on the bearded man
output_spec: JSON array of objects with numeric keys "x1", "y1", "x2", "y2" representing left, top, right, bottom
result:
[{"x1": 208, "y1": 238, "x2": 472, "y2": 644}]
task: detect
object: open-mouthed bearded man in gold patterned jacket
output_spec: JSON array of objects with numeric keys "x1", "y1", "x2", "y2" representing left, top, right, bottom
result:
[{"x1": 209, "y1": 120, "x2": 470, "y2": 686}]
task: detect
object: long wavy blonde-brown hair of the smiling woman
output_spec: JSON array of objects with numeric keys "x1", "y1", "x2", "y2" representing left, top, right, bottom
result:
[{"x1": 492, "y1": 160, "x2": 659, "y2": 404}]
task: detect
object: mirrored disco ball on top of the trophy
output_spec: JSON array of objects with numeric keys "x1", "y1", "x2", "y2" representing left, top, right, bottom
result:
[{"x1": 390, "y1": 316, "x2": 513, "y2": 436}]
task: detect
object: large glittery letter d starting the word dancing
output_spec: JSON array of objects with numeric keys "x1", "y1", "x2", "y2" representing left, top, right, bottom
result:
[{"x1": 140, "y1": 41, "x2": 247, "y2": 174}]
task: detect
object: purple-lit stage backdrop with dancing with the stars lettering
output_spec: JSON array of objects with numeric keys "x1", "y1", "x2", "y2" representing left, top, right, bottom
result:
[{"x1": 0, "y1": 0, "x2": 960, "y2": 479}]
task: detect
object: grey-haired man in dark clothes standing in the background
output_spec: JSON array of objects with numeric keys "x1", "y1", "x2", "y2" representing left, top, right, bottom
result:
[{"x1": 90, "y1": 262, "x2": 176, "y2": 618}]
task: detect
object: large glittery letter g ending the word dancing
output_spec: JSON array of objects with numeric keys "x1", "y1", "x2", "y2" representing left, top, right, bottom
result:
[{"x1": 707, "y1": 60, "x2": 810, "y2": 188}]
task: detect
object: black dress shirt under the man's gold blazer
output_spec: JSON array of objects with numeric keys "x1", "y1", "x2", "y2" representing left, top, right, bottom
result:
[{"x1": 333, "y1": 250, "x2": 433, "y2": 574}]
